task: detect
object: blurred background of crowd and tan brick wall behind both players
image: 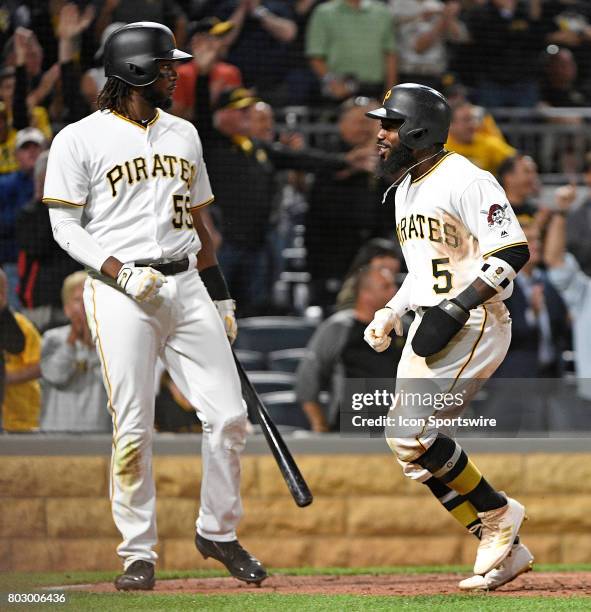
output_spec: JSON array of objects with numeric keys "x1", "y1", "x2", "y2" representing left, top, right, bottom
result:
[{"x1": 0, "y1": 0, "x2": 591, "y2": 570}]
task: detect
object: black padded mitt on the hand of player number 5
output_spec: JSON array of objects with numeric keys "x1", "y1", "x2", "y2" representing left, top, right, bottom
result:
[{"x1": 412, "y1": 300, "x2": 470, "y2": 357}]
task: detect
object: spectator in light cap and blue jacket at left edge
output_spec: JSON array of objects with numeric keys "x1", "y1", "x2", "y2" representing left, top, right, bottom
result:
[{"x1": 0, "y1": 128, "x2": 45, "y2": 308}]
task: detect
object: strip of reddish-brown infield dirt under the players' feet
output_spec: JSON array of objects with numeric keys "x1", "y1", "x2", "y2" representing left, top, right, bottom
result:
[{"x1": 78, "y1": 572, "x2": 591, "y2": 597}]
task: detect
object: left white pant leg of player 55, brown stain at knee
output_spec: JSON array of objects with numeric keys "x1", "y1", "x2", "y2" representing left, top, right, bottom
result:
[{"x1": 84, "y1": 279, "x2": 166, "y2": 567}]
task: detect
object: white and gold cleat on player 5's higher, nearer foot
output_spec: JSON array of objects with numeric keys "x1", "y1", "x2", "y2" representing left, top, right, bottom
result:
[{"x1": 474, "y1": 492, "x2": 525, "y2": 576}]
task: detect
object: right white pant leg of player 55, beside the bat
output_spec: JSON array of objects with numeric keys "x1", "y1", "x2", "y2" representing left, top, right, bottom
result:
[{"x1": 162, "y1": 271, "x2": 247, "y2": 541}]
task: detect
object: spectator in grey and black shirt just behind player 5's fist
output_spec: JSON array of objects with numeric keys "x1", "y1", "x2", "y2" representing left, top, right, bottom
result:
[{"x1": 296, "y1": 267, "x2": 404, "y2": 432}]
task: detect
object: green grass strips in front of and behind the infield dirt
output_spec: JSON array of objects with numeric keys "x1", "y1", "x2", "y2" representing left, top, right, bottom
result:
[{"x1": 0, "y1": 565, "x2": 591, "y2": 612}]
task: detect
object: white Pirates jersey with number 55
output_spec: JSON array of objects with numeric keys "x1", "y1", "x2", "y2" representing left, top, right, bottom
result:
[{"x1": 43, "y1": 110, "x2": 213, "y2": 262}]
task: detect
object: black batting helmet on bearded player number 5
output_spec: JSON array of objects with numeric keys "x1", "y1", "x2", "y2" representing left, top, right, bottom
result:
[{"x1": 366, "y1": 83, "x2": 451, "y2": 149}]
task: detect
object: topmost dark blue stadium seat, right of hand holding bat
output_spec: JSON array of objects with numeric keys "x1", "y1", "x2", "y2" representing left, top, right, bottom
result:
[{"x1": 234, "y1": 317, "x2": 316, "y2": 353}]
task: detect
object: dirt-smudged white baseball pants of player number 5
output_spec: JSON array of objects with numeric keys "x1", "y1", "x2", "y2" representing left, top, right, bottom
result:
[{"x1": 385, "y1": 302, "x2": 511, "y2": 482}]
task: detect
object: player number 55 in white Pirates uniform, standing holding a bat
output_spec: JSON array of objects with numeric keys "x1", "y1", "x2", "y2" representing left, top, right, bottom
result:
[{"x1": 44, "y1": 22, "x2": 267, "y2": 590}]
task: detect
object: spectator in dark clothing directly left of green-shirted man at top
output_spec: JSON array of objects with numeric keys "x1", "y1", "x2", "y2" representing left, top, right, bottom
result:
[{"x1": 215, "y1": 0, "x2": 297, "y2": 105}]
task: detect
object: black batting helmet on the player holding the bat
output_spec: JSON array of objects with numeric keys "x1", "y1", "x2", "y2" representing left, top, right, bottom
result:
[{"x1": 105, "y1": 21, "x2": 193, "y2": 87}]
